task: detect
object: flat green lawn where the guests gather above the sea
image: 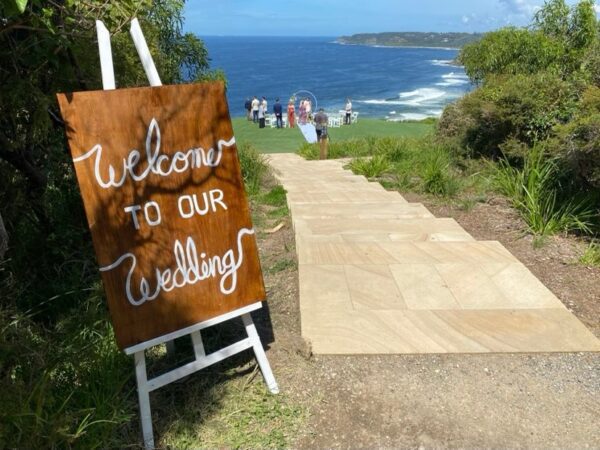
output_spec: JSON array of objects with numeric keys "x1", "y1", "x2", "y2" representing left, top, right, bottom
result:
[{"x1": 233, "y1": 118, "x2": 433, "y2": 153}]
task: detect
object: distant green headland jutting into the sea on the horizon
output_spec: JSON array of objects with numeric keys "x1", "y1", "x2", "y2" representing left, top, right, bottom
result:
[{"x1": 336, "y1": 32, "x2": 482, "y2": 48}]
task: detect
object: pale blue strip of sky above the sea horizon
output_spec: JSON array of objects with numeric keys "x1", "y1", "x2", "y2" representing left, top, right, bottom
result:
[{"x1": 185, "y1": 0, "x2": 600, "y2": 36}]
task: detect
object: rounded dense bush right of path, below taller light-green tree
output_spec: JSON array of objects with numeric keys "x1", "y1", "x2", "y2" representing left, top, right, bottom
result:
[{"x1": 437, "y1": 72, "x2": 579, "y2": 157}]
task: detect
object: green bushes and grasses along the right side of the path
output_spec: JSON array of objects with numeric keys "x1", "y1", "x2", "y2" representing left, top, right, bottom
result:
[{"x1": 300, "y1": 0, "x2": 600, "y2": 243}]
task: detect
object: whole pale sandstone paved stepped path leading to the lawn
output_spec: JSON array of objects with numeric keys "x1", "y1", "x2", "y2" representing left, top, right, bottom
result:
[{"x1": 269, "y1": 154, "x2": 600, "y2": 354}]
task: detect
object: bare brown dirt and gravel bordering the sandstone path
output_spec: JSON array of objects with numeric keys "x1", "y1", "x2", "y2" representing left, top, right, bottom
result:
[{"x1": 254, "y1": 194, "x2": 600, "y2": 449}]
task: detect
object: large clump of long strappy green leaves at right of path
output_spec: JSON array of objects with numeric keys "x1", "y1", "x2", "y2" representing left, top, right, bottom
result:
[{"x1": 496, "y1": 146, "x2": 594, "y2": 236}]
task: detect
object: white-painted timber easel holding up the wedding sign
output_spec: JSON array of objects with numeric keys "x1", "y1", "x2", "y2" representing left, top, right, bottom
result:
[{"x1": 96, "y1": 19, "x2": 279, "y2": 450}]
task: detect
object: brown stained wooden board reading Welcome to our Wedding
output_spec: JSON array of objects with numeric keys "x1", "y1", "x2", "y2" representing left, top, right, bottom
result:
[{"x1": 58, "y1": 82, "x2": 265, "y2": 349}]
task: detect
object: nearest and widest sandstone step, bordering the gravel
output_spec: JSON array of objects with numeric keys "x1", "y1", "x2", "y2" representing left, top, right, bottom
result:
[{"x1": 302, "y1": 309, "x2": 600, "y2": 355}]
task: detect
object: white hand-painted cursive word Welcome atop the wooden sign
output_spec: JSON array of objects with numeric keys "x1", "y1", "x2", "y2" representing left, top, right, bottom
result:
[{"x1": 73, "y1": 118, "x2": 235, "y2": 189}]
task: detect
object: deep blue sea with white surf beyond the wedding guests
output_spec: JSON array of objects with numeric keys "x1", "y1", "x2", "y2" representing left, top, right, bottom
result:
[{"x1": 201, "y1": 36, "x2": 471, "y2": 120}]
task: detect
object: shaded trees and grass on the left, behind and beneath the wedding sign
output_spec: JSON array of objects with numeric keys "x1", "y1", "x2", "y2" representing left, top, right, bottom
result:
[{"x1": 0, "y1": 0, "x2": 294, "y2": 448}]
